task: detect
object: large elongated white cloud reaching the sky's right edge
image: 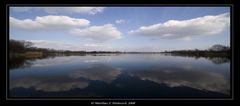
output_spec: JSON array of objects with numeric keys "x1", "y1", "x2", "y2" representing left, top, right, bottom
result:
[{"x1": 129, "y1": 13, "x2": 230, "y2": 40}]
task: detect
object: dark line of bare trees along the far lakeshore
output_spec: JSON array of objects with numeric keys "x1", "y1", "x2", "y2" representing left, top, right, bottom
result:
[{"x1": 9, "y1": 39, "x2": 230, "y2": 56}]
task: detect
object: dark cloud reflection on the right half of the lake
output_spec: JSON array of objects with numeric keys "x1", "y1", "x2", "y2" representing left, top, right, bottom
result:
[{"x1": 129, "y1": 67, "x2": 230, "y2": 94}]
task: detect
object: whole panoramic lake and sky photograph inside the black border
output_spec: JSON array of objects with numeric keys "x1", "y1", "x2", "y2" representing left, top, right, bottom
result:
[{"x1": 7, "y1": 6, "x2": 232, "y2": 99}]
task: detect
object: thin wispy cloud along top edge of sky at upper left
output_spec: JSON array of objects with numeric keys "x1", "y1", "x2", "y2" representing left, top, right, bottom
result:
[{"x1": 10, "y1": 7, "x2": 105, "y2": 15}]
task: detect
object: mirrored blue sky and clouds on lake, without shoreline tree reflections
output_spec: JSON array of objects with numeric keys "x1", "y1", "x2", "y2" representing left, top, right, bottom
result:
[{"x1": 9, "y1": 54, "x2": 230, "y2": 97}]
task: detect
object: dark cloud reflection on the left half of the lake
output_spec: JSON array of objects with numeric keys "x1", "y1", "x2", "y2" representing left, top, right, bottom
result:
[{"x1": 10, "y1": 64, "x2": 121, "y2": 92}]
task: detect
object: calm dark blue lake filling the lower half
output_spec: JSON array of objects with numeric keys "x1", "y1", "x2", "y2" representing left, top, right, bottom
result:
[{"x1": 8, "y1": 54, "x2": 231, "y2": 99}]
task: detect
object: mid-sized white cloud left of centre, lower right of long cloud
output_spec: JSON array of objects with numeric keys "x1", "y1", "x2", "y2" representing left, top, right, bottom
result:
[{"x1": 70, "y1": 24, "x2": 122, "y2": 41}]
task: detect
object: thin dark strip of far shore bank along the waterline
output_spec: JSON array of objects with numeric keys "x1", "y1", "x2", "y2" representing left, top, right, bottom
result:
[{"x1": 9, "y1": 51, "x2": 230, "y2": 58}]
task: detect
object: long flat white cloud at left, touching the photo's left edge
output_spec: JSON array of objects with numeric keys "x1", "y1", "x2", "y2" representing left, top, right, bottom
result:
[{"x1": 10, "y1": 15, "x2": 90, "y2": 30}]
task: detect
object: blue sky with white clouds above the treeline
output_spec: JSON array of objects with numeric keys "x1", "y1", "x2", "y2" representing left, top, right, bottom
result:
[{"x1": 9, "y1": 7, "x2": 230, "y2": 51}]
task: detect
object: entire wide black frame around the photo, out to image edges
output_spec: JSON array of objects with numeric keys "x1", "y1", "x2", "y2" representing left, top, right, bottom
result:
[{"x1": 0, "y1": 0, "x2": 239, "y2": 105}]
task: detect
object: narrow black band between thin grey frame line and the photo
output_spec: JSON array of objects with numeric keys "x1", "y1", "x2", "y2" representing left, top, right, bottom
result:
[{"x1": 6, "y1": 4, "x2": 233, "y2": 100}]
